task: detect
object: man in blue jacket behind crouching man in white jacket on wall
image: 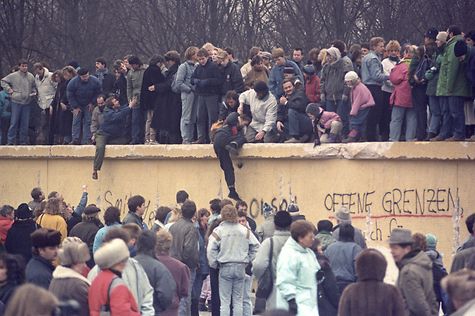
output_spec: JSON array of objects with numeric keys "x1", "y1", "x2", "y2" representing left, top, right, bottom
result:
[{"x1": 268, "y1": 48, "x2": 305, "y2": 100}]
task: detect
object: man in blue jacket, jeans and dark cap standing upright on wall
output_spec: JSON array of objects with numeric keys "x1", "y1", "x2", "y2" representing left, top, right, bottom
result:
[{"x1": 66, "y1": 68, "x2": 102, "y2": 145}]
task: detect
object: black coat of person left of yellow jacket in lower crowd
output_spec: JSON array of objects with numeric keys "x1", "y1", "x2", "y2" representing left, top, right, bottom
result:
[{"x1": 5, "y1": 219, "x2": 38, "y2": 264}]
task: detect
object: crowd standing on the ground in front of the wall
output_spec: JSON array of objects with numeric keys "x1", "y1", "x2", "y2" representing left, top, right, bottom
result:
[{"x1": 0, "y1": 187, "x2": 475, "y2": 316}]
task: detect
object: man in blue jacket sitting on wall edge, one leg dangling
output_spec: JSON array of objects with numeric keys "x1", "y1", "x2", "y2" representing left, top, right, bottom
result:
[{"x1": 92, "y1": 95, "x2": 137, "y2": 180}]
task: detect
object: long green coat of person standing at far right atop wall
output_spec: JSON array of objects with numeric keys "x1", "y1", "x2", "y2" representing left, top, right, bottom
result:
[{"x1": 437, "y1": 35, "x2": 472, "y2": 97}]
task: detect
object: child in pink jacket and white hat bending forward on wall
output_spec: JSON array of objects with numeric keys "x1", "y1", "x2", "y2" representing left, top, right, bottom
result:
[{"x1": 343, "y1": 71, "x2": 375, "y2": 143}]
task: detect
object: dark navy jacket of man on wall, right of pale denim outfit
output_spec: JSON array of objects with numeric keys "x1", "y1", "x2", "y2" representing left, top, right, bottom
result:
[{"x1": 191, "y1": 58, "x2": 223, "y2": 96}]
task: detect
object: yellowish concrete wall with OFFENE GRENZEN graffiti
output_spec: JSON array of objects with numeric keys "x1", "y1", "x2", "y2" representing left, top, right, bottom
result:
[{"x1": 0, "y1": 143, "x2": 475, "y2": 263}]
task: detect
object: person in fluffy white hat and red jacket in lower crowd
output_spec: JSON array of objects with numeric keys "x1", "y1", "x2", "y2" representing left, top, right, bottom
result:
[{"x1": 89, "y1": 238, "x2": 140, "y2": 316}]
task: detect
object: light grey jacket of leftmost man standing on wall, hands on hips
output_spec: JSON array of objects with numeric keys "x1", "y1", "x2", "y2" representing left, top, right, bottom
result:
[{"x1": 0, "y1": 70, "x2": 37, "y2": 104}]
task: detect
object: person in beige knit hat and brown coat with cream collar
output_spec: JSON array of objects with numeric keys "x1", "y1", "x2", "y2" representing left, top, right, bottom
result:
[{"x1": 49, "y1": 237, "x2": 91, "y2": 316}]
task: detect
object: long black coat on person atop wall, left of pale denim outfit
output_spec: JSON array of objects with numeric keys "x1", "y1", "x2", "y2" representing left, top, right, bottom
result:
[{"x1": 152, "y1": 64, "x2": 181, "y2": 135}]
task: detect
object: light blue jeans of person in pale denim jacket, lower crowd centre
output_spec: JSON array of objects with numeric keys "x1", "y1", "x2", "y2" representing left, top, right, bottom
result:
[{"x1": 219, "y1": 263, "x2": 246, "y2": 316}]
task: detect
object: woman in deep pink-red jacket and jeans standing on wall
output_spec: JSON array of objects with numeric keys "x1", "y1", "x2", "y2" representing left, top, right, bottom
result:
[{"x1": 389, "y1": 46, "x2": 417, "y2": 142}]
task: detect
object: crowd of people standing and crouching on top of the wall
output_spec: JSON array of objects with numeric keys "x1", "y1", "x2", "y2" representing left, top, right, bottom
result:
[{"x1": 0, "y1": 26, "x2": 475, "y2": 147}]
